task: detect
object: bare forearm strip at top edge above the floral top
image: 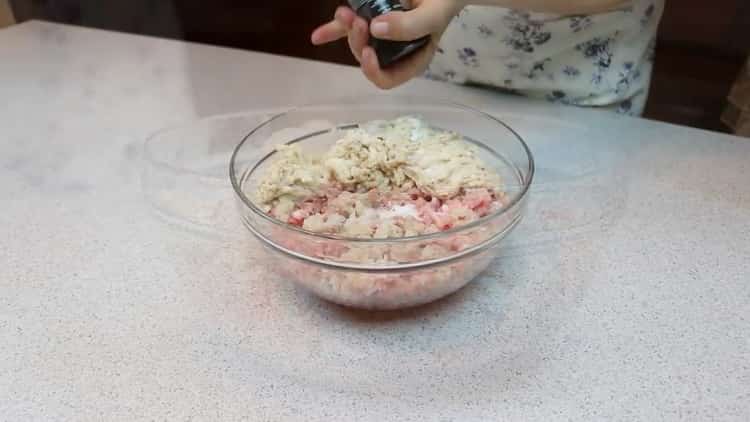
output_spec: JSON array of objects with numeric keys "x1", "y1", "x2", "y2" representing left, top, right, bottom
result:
[{"x1": 457, "y1": 0, "x2": 631, "y2": 15}]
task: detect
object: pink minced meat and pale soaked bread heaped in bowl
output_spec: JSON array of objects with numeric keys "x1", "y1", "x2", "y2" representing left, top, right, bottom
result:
[{"x1": 255, "y1": 117, "x2": 505, "y2": 239}]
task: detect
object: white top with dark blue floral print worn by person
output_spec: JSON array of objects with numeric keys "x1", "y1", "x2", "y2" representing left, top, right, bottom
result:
[{"x1": 426, "y1": 0, "x2": 664, "y2": 115}]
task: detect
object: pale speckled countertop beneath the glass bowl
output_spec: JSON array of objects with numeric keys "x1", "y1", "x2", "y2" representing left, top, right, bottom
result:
[{"x1": 0, "y1": 22, "x2": 750, "y2": 421}]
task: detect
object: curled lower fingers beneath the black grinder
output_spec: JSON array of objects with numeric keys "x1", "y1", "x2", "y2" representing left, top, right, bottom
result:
[{"x1": 361, "y1": 44, "x2": 435, "y2": 89}]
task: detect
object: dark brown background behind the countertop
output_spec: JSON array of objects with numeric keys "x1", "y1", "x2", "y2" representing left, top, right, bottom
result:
[{"x1": 11, "y1": 0, "x2": 750, "y2": 131}]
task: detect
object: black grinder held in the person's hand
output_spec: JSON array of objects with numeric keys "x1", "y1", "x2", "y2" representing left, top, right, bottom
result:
[{"x1": 349, "y1": 0, "x2": 430, "y2": 68}]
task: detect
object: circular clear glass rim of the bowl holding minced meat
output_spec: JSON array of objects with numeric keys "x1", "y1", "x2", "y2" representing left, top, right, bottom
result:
[{"x1": 229, "y1": 95, "x2": 536, "y2": 244}]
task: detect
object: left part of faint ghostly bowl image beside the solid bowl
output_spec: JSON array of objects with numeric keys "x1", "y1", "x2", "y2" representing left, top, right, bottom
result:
[{"x1": 141, "y1": 109, "x2": 285, "y2": 239}]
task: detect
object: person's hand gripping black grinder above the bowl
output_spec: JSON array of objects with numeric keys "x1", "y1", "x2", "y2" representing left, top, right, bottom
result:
[{"x1": 311, "y1": 0, "x2": 465, "y2": 89}]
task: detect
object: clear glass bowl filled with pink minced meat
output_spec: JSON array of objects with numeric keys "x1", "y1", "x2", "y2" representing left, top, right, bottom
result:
[{"x1": 230, "y1": 95, "x2": 534, "y2": 310}]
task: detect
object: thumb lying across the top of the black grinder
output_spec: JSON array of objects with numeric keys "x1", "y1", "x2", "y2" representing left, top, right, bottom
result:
[{"x1": 370, "y1": 0, "x2": 458, "y2": 41}]
